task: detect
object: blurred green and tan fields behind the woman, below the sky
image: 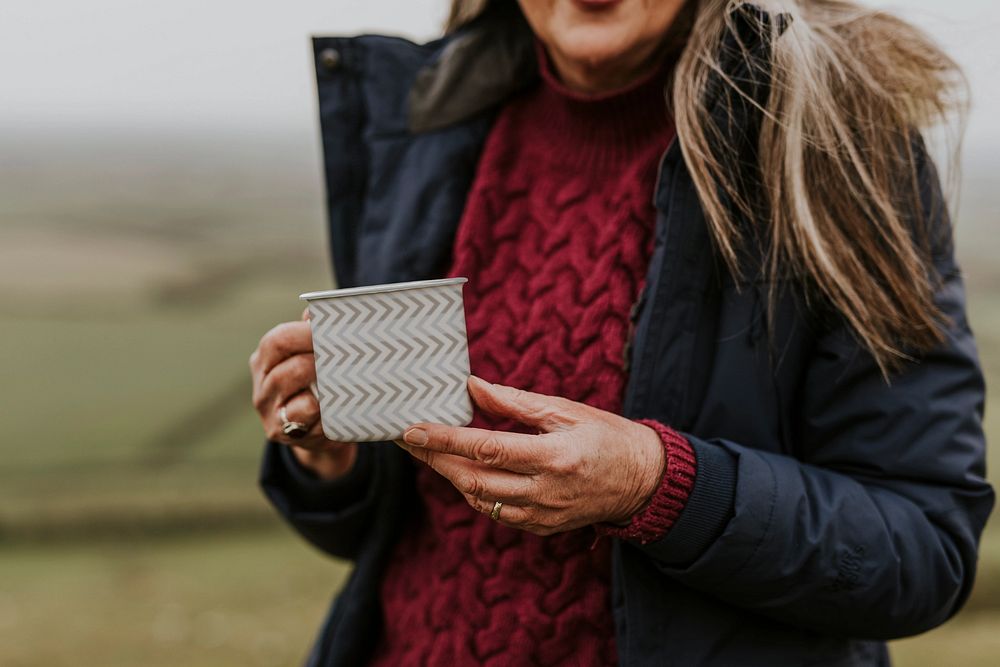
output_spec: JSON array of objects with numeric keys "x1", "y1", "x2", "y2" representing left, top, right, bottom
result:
[{"x1": 0, "y1": 134, "x2": 1000, "y2": 667}]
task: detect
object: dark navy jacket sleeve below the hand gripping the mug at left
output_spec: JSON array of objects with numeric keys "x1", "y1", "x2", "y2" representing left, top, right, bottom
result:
[{"x1": 260, "y1": 442, "x2": 384, "y2": 560}]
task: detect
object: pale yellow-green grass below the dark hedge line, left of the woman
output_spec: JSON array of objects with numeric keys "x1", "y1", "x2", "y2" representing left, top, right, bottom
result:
[{"x1": 0, "y1": 525, "x2": 347, "y2": 667}]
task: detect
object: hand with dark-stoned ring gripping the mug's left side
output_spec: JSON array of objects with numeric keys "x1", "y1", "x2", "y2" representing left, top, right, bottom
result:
[{"x1": 250, "y1": 310, "x2": 358, "y2": 479}]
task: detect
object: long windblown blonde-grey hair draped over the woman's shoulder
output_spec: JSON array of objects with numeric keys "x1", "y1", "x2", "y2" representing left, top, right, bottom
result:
[{"x1": 450, "y1": 0, "x2": 966, "y2": 376}]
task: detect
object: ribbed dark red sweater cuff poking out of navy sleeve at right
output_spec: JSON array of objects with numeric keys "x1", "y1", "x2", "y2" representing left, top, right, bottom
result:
[{"x1": 594, "y1": 419, "x2": 698, "y2": 544}]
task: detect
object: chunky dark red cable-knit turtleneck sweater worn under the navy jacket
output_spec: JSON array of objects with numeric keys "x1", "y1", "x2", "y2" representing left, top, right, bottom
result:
[{"x1": 375, "y1": 49, "x2": 695, "y2": 667}]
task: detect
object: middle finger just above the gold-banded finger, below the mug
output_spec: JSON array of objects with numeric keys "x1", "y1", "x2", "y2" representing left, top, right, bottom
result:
[{"x1": 401, "y1": 442, "x2": 538, "y2": 503}]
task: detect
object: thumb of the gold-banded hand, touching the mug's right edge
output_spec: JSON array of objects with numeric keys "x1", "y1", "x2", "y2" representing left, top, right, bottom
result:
[{"x1": 469, "y1": 375, "x2": 582, "y2": 433}]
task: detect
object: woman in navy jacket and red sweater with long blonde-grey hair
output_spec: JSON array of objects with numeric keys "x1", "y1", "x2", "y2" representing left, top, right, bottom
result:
[{"x1": 251, "y1": 0, "x2": 993, "y2": 666}]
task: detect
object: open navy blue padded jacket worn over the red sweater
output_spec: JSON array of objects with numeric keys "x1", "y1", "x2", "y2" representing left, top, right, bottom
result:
[{"x1": 261, "y1": 3, "x2": 993, "y2": 667}]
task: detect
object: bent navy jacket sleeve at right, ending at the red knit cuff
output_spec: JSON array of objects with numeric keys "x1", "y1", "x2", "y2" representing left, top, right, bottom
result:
[{"x1": 633, "y1": 150, "x2": 994, "y2": 639}]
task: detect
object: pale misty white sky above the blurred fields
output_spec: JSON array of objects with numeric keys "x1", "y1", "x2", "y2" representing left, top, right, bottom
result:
[{"x1": 0, "y1": 0, "x2": 1000, "y2": 152}]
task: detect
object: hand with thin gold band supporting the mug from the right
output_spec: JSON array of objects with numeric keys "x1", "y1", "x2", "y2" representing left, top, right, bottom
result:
[{"x1": 397, "y1": 376, "x2": 665, "y2": 535}]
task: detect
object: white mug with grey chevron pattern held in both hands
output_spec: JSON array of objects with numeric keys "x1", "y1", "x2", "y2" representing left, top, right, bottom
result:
[{"x1": 302, "y1": 278, "x2": 472, "y2": 442}]
